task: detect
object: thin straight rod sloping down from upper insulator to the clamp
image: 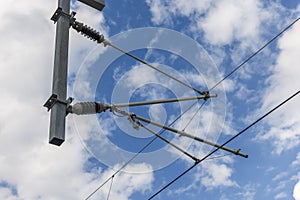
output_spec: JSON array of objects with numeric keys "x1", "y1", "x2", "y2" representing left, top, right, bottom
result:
[{"x1": 104, "y1": 40, "x2": 205, "y2": 95}]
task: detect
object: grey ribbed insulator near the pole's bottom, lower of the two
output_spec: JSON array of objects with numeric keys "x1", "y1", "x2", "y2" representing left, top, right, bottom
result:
[{"x1": 72, "y1": 102, "x2": 107, "y2": 115}]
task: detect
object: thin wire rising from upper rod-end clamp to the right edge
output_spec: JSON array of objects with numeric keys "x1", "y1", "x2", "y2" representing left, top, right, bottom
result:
[{"x1": 209, "y1": 17, "x2": 300, "y2": 91}]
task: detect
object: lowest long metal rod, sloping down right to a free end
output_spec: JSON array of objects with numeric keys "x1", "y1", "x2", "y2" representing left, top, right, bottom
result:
[{"x1": 133, "y1": 115, "x2": 248, "y2": 158}]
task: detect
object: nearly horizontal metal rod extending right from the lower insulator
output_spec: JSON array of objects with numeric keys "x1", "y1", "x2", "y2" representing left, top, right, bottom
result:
[{"x1": 112, "y1": 94, "x2": 217, "y2": 108}]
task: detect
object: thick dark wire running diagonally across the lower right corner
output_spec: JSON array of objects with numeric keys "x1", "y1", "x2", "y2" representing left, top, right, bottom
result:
[{"x1": 148, "y1": 90, "x2": 300, "y2": 200}]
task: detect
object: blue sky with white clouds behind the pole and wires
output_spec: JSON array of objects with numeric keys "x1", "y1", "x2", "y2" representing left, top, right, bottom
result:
[{"x1": 0, "y1": 0, "x2": 300, "y2": 200}]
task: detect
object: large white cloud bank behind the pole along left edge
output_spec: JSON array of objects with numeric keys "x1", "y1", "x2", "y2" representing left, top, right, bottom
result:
[{"x1": 0, "y1": 0, "x2": 153, "y2": 200}]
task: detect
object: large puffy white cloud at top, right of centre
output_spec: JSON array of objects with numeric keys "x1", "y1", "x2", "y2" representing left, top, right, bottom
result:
[{"x1": 147, "y1": 0, "x2": 294, "y2": 85}]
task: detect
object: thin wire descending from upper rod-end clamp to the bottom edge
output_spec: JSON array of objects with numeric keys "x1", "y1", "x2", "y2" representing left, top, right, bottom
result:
[{"x1": 85, "y1": 101, "x2": 198, "y2": 200}]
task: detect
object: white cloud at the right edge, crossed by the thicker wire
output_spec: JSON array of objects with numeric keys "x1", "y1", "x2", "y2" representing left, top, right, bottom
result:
[{"x1": 255, "y1": 19, "x2": 300, "y2": 154}]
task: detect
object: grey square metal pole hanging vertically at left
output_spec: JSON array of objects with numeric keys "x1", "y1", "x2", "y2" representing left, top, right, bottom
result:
[{"x1": 49, "y1": 0, "x2": 70, "y2": 146}]
